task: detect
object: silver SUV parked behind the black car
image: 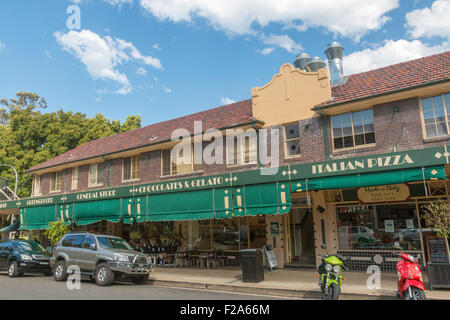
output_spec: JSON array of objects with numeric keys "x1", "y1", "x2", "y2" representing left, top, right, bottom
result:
[{"x1": 50, "y1": 232, "x2": 152, "y2": 286}]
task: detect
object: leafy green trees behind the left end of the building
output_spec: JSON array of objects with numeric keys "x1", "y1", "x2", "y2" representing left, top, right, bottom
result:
[{"x1": 0, "y1": 92, "x2": 141, "y2": 197}]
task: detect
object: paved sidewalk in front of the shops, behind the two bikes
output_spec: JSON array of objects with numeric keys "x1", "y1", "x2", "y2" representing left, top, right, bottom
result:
[{"x1": 150, "y1": 267, "x2": 450, "y2": 300}]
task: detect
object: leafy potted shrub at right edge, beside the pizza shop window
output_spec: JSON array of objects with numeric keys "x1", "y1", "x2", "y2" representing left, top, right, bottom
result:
[{"x1": 423, "y1": 200, "x2": 450, "y2": 239}]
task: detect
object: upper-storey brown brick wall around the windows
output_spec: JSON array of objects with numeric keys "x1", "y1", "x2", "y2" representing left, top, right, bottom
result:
[{"x1": 31, "y1": 94, "x2": 450, "y2": 195}]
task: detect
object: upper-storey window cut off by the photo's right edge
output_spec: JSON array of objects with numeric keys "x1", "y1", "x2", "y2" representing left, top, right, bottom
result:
[{"x1": 421, "y1": 93, "x2": 450, "y2": 138}]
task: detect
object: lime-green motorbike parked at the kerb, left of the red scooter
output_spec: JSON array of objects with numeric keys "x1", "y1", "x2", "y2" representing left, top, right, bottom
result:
[{"x1": 317, "y1": 244, "x2": 348, "y2": 300}]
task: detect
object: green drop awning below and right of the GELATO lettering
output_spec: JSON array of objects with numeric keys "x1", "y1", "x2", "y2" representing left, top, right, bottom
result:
[{"x1": 233, "y1": 182, "x2": 292, "y2": 216}]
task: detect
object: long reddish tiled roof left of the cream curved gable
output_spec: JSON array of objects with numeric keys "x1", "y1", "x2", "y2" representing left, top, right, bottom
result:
[{"x1": 28, "y1": 100, "x2": 255, "y2": 171}]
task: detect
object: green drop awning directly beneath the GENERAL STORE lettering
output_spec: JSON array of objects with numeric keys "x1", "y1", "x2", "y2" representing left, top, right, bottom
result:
[{"x1": 73, "y1": 199, "x2": 122, "y2": 226}]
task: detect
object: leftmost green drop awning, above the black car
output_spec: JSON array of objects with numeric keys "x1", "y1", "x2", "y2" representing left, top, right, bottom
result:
[{"x1": 19, "y1": 205, "x2": 57, "y2": 230}]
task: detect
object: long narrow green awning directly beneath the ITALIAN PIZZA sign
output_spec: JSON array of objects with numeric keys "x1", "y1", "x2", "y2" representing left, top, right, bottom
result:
[{"x1": 292, "y1": 166, "x2": 446, "y2": 192}]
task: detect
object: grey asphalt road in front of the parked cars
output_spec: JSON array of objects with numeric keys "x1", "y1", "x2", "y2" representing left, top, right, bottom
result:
[{"x1": 0, "y1": 272, "x2": 286, "y2": 300}]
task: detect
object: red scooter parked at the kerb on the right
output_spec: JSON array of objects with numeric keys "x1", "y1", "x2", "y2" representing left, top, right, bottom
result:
[{"x1": 394, "y1": 242, "x2": 425, "y2": 300}]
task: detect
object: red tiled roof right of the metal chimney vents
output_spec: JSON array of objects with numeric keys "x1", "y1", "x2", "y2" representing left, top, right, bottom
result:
[{"x1": 314, "y1": 51, "x2": 450, "y2": 109}]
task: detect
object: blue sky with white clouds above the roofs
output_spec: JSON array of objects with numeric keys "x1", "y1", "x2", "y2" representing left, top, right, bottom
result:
[{"x1": 0, "y1": 0, "x2": 450, "y2": 125}]
